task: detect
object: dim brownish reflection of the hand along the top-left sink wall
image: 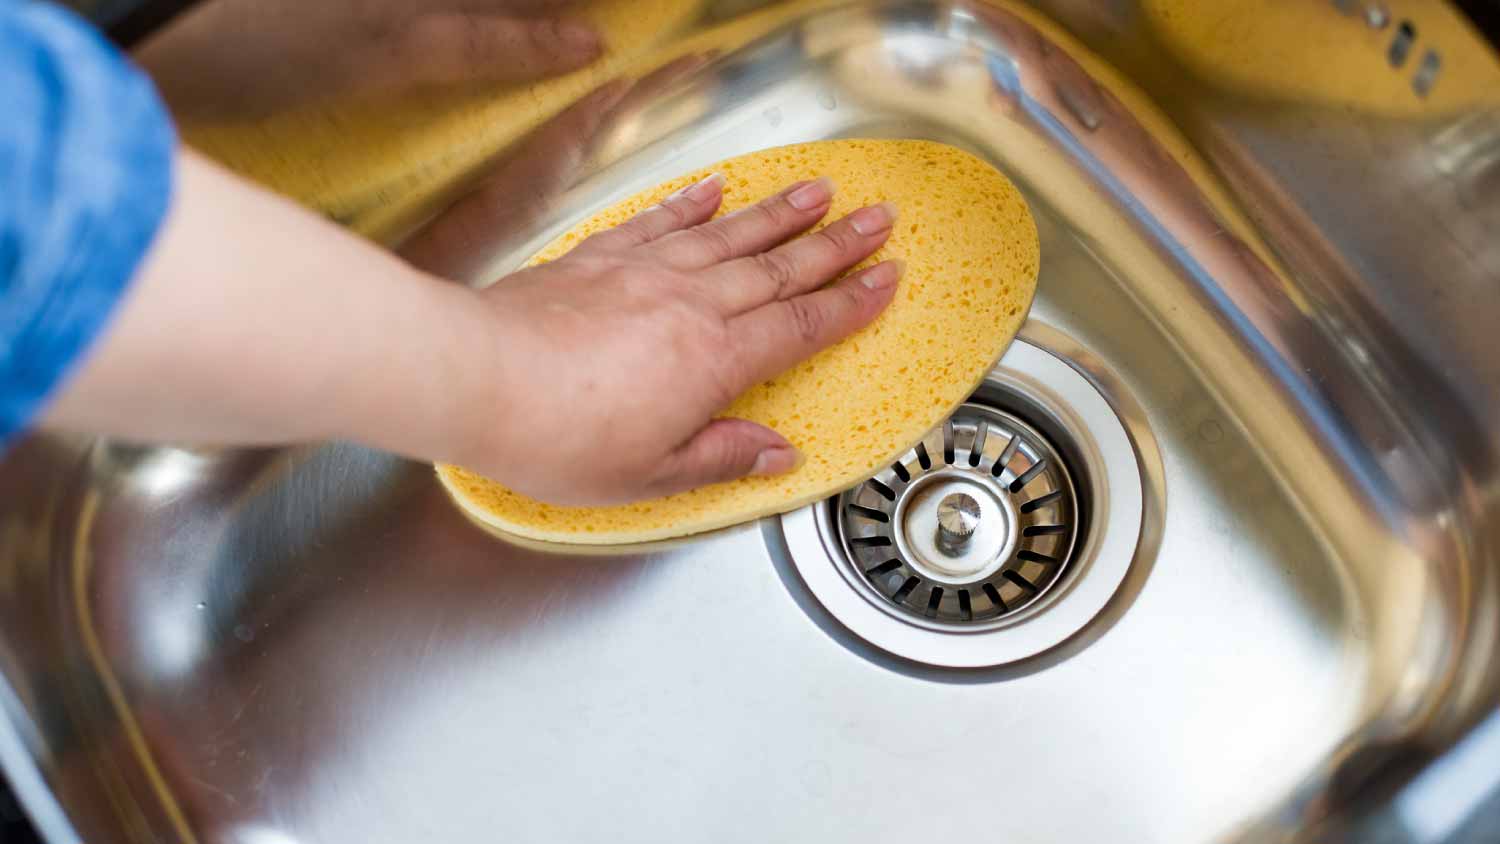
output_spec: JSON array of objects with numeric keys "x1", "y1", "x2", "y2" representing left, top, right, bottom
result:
[{"x1": 134, "y1": 0, "x2": 603, "y2": 120}]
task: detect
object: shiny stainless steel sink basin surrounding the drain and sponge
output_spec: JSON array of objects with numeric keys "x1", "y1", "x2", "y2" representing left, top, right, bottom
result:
[{"x1": 0, "y1": 0, "x2": 1500, "y2": 844}]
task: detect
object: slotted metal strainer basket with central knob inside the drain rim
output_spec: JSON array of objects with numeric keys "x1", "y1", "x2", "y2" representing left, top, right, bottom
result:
[{"x1": 836, "y1": 403, "x2": 1079, "y2": 625}]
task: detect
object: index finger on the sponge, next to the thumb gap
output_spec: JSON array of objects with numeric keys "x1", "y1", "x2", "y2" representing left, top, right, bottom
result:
[{"x1": 729, "y1": 261, "x2": 903, "y2": 394}]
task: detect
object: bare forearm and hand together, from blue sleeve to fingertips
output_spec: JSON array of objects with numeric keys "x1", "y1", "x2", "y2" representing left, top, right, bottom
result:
[{"x1": 44, "y1": 150, "x2": 900, "y2": 504}]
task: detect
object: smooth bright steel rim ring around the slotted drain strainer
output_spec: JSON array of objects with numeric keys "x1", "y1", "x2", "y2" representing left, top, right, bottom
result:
[{"x1": 782, "y1": 339, "x2": 1145, "y2": 669}]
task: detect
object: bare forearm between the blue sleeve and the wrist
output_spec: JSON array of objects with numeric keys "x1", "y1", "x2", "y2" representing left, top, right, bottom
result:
[{"x1": 44, "y1": 150, "x2": 486, "y2": 459}]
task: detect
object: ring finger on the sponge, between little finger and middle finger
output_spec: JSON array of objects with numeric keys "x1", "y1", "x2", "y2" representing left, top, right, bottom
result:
[{"x1": 653, "y1": 178, "x2": 834, "y2": 270}]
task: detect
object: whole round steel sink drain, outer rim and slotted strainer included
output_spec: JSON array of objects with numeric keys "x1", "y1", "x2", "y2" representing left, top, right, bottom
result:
[{"x1": 780, "y1": 334, "x2": 1149, "y2": 667}]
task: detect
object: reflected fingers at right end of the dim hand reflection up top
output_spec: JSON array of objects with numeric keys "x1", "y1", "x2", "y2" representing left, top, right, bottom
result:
[{"x1": 401, "y1": 10, "x2": 603, "y2": 85}]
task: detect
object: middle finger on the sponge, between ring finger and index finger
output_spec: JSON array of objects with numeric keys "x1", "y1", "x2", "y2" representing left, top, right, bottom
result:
[{"x1": 699, "y1": 202, "x2": 896, "y2": 315}]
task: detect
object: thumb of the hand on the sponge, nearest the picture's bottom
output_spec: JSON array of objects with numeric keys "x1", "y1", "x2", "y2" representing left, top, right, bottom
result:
[{"x1": 657, "y1": 420, "x2": 803, "y2": 495}]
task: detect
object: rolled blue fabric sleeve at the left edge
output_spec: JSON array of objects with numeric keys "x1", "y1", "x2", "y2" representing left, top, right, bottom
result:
[{"x1": 0, "y1": 0, "x2": 177, "y2": 450}]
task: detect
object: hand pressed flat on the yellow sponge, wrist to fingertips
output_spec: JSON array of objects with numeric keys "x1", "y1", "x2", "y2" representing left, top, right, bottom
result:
[{"x1": 453, "y1": 177, "x2": 902, "y2": 504}]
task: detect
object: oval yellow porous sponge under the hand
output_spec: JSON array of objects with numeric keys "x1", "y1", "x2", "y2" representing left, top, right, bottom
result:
[{"x1": 438, "y1": 141, "x2": 1040, "y2": 544}]
